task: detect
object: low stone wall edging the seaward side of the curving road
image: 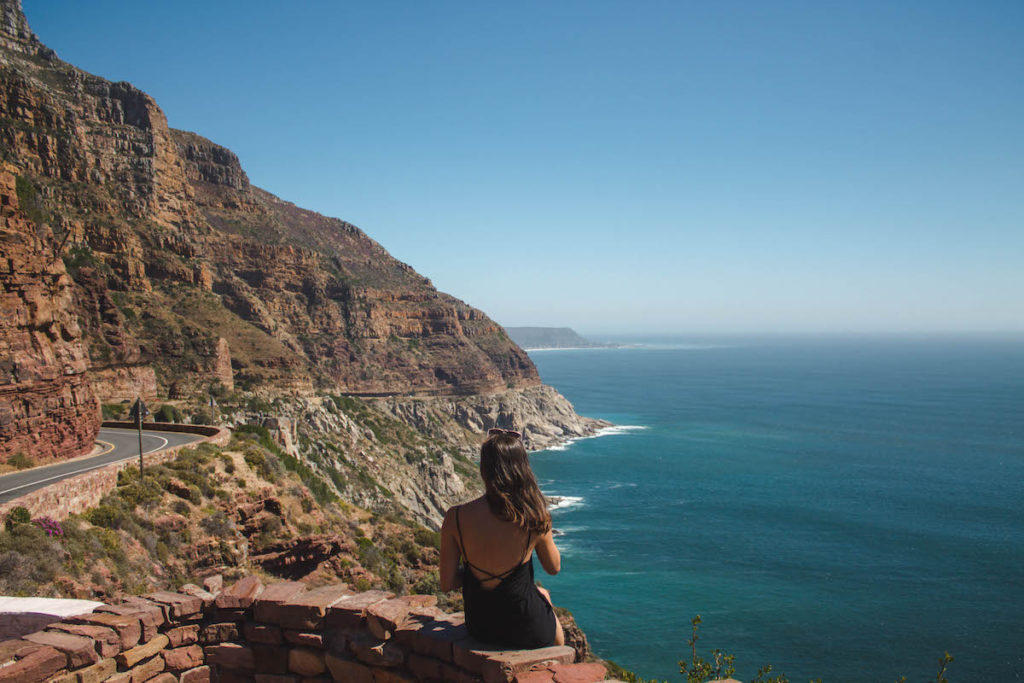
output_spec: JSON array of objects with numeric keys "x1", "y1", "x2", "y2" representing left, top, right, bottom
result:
[{"x1": 0, "y1": 422, "x2": 231, "y2": 519}]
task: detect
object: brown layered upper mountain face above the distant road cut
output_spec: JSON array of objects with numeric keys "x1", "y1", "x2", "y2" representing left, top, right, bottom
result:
[{"x1": 0, "y1": 0, "x2": 540, "y2": 395}]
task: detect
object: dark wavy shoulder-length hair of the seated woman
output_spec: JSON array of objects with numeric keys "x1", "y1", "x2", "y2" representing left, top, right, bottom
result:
[{"x1": 480, "y1": 432, "x2": 551, "y2": 533}]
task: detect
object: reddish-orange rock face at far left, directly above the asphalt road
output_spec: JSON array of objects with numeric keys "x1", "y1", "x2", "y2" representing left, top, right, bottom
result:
[{"x1": 0, "y1": 166, "x2": 99, "y2": 461}]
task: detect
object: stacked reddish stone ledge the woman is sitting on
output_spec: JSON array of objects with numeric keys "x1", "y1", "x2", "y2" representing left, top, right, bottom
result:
[{"x1": 0, "y1": 577, "x2": 622, "y2": 683}]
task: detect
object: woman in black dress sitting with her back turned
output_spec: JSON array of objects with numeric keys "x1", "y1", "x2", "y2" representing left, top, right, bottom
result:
[{"x1": 440, "y1": 429, "x2": 565, "y2": 648}]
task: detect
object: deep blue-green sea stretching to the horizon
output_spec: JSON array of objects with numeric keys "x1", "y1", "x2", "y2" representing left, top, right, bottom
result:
[{"x1": 530, "y1": 336, "x2": 1024, "y2": 683}]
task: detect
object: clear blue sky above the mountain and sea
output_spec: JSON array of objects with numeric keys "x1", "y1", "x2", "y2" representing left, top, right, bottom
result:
[{"x1": 25, "y1": 0, "x2": 1024, "y2": 334}]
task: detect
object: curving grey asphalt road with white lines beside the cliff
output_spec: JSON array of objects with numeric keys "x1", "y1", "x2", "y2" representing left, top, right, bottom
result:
[{"x1": 0, "y1": 427, "x2": 203, "y2": 503}]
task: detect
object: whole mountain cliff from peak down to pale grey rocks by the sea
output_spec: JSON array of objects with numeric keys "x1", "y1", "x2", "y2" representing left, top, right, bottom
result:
[{"x1": 0, "y1": 0, "x2": 601, "y2": 518}]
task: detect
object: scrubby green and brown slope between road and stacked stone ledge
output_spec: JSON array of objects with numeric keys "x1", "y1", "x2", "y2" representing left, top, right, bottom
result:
[{"x1": 0, "y1": 438, "x2": 448, "y2": 599}]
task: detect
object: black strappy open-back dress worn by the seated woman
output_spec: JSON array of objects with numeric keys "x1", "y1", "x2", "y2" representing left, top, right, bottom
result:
[{"x1": 455, "y1": 508, "x2": 555, "y2": 649}]
